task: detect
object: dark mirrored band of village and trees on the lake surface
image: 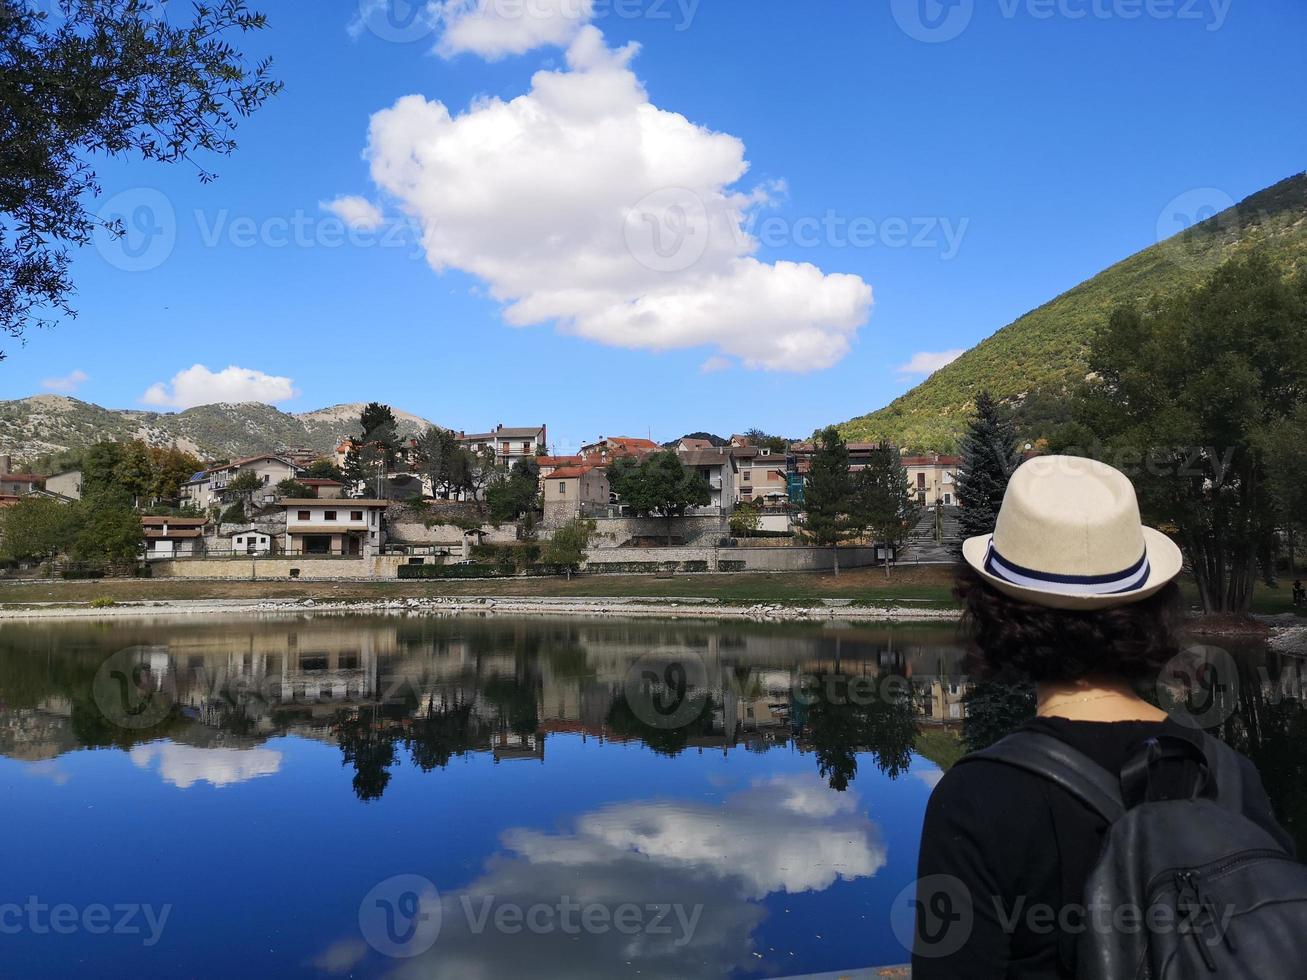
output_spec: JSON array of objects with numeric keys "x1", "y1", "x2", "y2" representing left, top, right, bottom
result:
[{"x1": 0, "y1": 618, "x2": 967, "y2": 801}]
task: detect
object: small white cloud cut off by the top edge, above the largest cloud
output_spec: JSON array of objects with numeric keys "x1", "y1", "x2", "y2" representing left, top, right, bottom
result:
[{"x1": 435, "y1": 0, "x2": 595, "y2": 60}]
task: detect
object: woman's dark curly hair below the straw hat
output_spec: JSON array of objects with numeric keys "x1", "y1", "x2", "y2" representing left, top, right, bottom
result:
[{"x1": 953, "y1": 564, "x2": 1183, "y2": 682}]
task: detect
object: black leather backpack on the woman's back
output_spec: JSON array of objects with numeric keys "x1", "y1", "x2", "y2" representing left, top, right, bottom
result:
[{"x1": 962, "y1": 732, "x2": 1307, "y2": 980}]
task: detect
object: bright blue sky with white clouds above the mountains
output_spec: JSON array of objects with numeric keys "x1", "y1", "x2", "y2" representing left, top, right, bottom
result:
[{"x1": 0, "y1": 0, "x2": 1307, "y2": 448}]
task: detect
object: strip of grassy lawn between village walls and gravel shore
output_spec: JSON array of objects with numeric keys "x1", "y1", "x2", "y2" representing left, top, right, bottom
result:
[{"x1": 0, "y1": 566, "x2": 954, "y2": 608}]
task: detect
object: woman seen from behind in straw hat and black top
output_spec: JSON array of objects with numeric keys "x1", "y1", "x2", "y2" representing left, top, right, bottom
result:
[{"x1": 912, "y1": 456, "x2": 1291, "y2": 980}]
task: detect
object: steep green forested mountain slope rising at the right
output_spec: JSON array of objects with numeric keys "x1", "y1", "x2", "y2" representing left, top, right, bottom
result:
[{"x1": 838, "y1": 174, "x2": 1307, "y2": 451}]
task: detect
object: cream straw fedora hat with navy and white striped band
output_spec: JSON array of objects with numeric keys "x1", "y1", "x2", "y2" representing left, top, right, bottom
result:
[{"x1": 962, "y1": 456, "x2": 1182, "y2": 609}]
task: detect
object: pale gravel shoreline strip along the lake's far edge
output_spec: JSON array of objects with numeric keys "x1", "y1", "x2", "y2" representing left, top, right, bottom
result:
[{"x1": 0, "y1": 596, "x2": 961, "y2": 622}]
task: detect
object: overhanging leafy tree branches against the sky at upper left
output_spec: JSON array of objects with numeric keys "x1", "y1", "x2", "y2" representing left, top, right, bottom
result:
[{"x1": 0, "y1": 0, "x2": 281, "y2": 358}]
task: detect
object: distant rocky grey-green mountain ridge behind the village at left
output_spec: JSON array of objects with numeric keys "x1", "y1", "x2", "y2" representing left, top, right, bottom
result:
[{"x1": 0, "y1": 395, "x2": 431, "y2": 460}]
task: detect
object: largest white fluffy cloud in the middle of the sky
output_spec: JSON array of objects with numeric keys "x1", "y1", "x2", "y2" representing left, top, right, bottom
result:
[{"x1": 367, "y1": 26, "x2": 872, "y2": 371}]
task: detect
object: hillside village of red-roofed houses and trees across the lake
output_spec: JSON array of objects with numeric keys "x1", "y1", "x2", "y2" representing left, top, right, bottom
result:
[{"x1": 0, "y1": 402, "x2": 959, "y2": 579}]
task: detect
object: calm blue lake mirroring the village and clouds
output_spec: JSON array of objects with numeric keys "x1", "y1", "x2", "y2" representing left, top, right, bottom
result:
[{"x1": 0, "y1": 615, "x2": 1307, "y2": 977}]
